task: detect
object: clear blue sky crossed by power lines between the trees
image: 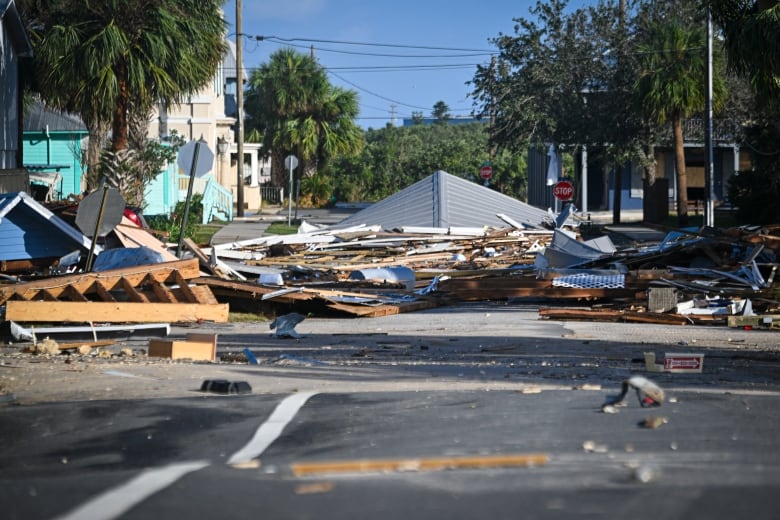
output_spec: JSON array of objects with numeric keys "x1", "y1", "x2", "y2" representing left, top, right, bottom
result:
[{"x1": 224, "y1": 0, "x2": 581, "y2": 128}]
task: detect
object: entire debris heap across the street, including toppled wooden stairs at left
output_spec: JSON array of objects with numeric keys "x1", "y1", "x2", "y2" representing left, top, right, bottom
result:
[{"x1": 0, "y1": 188, "x2": 780, "y2": 338}]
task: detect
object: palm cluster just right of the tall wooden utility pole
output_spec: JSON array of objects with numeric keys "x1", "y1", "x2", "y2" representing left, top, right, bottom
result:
[{"x1": 245, "y1": 48, "x2": 363, "y2": 190}]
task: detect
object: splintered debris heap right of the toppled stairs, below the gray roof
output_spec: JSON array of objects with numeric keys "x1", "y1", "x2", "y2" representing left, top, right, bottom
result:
[{"x1": 197, "y1": 217, "x2": 780, "y2": 326}]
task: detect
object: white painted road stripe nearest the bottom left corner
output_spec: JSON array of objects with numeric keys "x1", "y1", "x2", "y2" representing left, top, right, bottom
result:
[{"x1": 55, "y1": 461, "x2": 209, "y2": 520}]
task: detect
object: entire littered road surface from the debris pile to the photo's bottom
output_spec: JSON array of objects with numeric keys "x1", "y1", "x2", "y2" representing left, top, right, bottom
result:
[{"x1": 0, "y1": 304, "x2": 780, "y2": 520}]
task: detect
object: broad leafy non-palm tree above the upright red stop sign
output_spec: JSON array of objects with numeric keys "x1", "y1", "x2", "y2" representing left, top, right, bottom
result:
[{"x1": 471, "y1": 0, "x2": 646, "y2": 216}]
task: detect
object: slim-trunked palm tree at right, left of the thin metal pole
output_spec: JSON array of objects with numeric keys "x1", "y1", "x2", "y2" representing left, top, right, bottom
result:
[{"x1": 634, "y1": 20, "x2": 725, "y2": 226}]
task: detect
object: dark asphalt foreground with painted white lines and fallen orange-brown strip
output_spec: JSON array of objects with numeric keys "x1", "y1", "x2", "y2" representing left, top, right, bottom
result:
[{"x1": 0, "y1": 391, "x2": 780, "y2": 519}]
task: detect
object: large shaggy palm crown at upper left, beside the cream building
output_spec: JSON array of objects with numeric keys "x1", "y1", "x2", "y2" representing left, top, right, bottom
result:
[{"x1": 23, "y1": 0, "x2": 226, "y2": 151}]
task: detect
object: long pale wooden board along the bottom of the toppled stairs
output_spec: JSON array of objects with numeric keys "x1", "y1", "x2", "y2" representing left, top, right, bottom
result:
[{"x1": 6, "y1": 300, "x2": 229, "y2": 323}]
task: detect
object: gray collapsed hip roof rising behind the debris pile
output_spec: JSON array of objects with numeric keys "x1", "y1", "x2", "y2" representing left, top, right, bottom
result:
[{"x1": 339, "y1": 170, "x2": 548, "y2": 230}]
